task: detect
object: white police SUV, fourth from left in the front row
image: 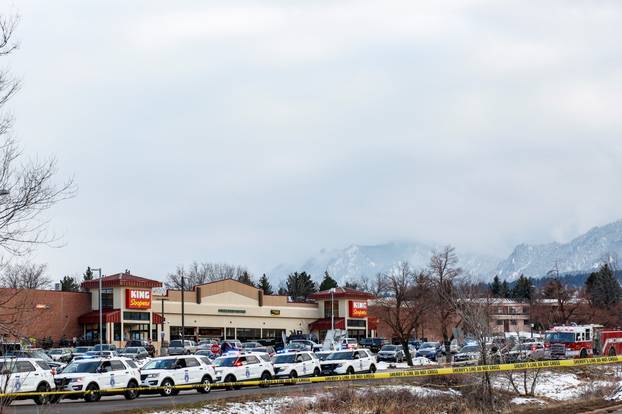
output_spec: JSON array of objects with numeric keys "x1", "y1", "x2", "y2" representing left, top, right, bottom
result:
[{"x1": 214, "y1": 353, "x2": 274, "y2": 389}]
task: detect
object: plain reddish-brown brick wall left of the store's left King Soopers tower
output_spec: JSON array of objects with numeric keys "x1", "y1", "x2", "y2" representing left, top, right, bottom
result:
[{"x1": 0, "y1": 288, "x2": 91, "y2": 342}]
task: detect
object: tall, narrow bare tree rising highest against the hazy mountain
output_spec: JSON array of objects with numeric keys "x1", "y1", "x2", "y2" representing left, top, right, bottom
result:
[{"x1": 428, "y1": 246, "x2": 462, "y2": 354}]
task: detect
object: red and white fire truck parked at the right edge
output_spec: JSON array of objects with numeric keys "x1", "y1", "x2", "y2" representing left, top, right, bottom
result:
[{"x1": 544, "y1": 325, "x2": 622, "y2": 359}]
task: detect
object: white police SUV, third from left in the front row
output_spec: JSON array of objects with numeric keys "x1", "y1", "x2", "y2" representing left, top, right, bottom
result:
[{"x1": 140, "y1": 355, "x2": 220, "y2": 397}]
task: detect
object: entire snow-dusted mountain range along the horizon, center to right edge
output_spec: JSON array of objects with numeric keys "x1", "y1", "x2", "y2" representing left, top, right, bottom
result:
[{"x1": 271, "y1": 220, "x2": 622, "y2": 284}]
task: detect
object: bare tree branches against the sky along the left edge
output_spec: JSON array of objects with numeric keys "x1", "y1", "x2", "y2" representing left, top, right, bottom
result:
[{"x1": 0, "y1": 16, "x2": 75, "y2": 255}]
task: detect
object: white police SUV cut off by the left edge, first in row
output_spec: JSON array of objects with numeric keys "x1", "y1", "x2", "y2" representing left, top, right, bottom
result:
[{"x1": 0, "y1": 358, "x2": 54, "y2": 405}]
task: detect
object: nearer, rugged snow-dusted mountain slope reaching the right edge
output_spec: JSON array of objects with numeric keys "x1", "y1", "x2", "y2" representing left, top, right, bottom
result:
[{"x1": 496, "y1": 220, "x2": 622, "y2": 280}]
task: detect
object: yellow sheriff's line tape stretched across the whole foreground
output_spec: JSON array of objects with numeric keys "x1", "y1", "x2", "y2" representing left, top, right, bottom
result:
[{"x1": 0, "y1": 356, "x2": 622, "y2": 398}]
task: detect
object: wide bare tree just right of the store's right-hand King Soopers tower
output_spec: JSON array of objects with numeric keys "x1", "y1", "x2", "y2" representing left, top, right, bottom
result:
[{"x1": 375, "y1": 262, "x2": 430, "y2": 366}]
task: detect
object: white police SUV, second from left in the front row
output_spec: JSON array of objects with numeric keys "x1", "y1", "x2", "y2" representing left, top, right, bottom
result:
[{"x1": 54, "y1": 358, "x2": 140, "y2": 402}]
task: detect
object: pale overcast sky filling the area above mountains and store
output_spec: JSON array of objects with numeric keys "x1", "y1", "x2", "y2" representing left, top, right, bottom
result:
[{"x1": 0, "y1": 0, "x2": 622, "y2": 278}]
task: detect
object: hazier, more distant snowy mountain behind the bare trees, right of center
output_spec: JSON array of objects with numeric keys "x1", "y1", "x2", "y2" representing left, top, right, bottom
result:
[{"x1": 271, "y1": 242, "x2": 499, "y2": 284}]
